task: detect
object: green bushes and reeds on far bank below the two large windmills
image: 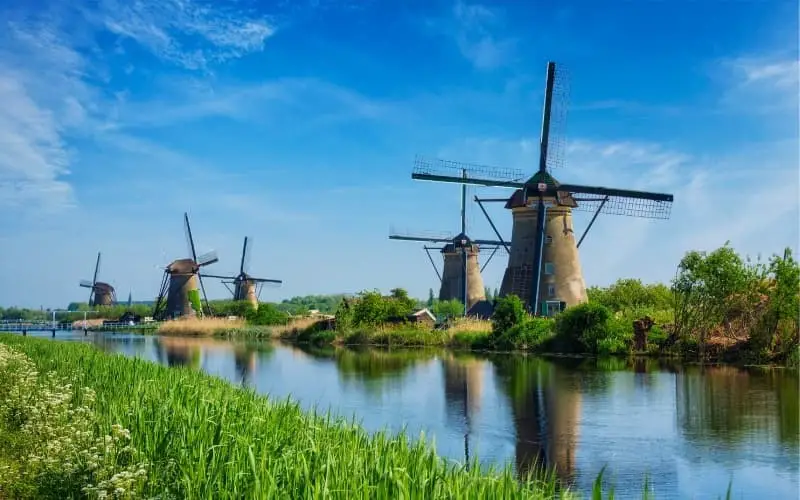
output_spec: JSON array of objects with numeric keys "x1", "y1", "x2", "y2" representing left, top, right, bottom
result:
[{"x1": 278, "y1": 245, "x2": 800, "y2": 366}]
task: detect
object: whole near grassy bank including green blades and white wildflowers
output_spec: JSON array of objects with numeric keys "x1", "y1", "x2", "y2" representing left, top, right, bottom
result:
[{"x1": 0, "y1": 335, "x2": 570, "y2": 498}]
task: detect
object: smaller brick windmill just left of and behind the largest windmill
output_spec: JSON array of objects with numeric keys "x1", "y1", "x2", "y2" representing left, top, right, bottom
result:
[{"x1": 389, "y1": 171, "x2": 507, "y2": 315}]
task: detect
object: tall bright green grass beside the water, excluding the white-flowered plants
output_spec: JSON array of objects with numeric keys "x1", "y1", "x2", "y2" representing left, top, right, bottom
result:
[{"x1": 0, "y1": 335, "x2": 572, "y2": 499}]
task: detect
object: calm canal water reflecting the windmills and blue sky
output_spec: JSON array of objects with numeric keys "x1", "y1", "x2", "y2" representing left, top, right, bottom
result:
[{"x1": 26, "y1": 332, "x2": 800, "y2": 499}]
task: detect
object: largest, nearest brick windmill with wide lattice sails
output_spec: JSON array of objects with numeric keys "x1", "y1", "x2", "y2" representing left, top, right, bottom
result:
[{"x1": 411, "y1": 62, "x2": 673, "y2": 315}]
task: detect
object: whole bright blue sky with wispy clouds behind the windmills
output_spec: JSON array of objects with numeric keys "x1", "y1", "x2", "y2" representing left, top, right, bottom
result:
[{"x1": 0, "y1": 0, "x2": 800, "y2": 307}]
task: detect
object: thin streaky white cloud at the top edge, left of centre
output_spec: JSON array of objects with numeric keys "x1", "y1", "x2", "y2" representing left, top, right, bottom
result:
[{"x1": 92, "y1": 0, "x2": 275, "y2": 70}]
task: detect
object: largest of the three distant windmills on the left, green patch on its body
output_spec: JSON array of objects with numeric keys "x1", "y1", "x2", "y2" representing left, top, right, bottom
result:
[{"x1": 153, "y1": 212, "x2": 219, "y2": 320}]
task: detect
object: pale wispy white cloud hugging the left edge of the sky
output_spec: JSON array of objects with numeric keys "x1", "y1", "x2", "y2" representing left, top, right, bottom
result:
[{"x1": 0, "y1": 23, "x2": 88, "y2": 211}]
